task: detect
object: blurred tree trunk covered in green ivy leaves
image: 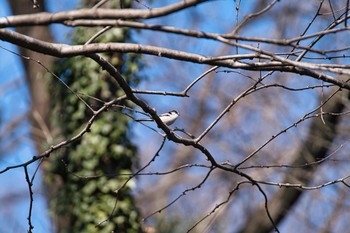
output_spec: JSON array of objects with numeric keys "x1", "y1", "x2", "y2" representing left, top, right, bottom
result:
[{"x1": 46, "y1": 1, "x2": 142, "y2": 233}]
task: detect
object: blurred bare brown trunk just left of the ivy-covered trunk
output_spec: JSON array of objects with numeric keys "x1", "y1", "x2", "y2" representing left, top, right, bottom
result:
[{"x1": 8, "y1": 0, "x2": 54, "y2": 151}]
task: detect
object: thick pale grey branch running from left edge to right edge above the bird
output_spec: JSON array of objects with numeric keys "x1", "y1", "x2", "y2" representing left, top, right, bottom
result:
[{"x1": 0, "y1": 29, "x2": 350, "y2": 90}]
